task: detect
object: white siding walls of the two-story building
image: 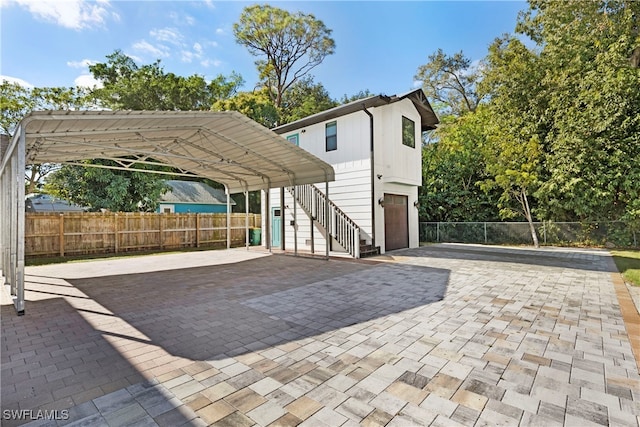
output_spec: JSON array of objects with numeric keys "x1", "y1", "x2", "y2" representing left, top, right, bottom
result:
[{"x1": 263, "y1": 99, "x2": 422, "y2": 253}]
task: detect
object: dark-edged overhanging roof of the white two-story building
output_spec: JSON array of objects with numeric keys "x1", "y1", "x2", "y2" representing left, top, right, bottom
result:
[{"x1": 273, "y1": 89, "x2": 440, "y2": 134}]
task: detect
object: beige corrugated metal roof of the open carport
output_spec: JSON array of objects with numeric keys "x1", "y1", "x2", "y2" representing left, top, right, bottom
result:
[{"x1": 21, "y1": 111, "x2": 335, "y2": 193}]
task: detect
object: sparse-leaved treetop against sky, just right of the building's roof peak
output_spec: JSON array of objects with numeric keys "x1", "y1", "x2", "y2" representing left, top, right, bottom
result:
[{"x1": 414, "y1": 49, "x2": 483, "y2": 116}]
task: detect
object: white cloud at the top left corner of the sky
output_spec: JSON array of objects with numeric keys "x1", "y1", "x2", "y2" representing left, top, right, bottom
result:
[{"x1": 7, "y1": 0, "x2": 119, "y2": 30}]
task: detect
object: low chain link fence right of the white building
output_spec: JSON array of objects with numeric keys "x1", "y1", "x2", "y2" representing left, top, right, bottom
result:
[{"x1": 420, "y1": 221, "x2": 640, "y2": 248}]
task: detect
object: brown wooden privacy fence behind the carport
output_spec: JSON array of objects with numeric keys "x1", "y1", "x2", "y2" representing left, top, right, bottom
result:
[{"x1": 25, "y1": 212, "x2": 261, "y2": 257}]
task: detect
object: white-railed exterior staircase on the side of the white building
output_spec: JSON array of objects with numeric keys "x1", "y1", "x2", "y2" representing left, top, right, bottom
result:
[{"x1": 287, "y1": 184, "x2": 380, "y2": 258}]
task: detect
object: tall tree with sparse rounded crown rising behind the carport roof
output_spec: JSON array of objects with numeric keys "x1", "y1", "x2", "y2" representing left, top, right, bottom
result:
[{"x1": 233, "y1": 4, "x2": 335, "y2": 108}]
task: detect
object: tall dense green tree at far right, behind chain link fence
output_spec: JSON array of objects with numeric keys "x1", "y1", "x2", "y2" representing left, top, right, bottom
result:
[{"x1": 517, "y1": 0, "x2": 640, "y2": 221}]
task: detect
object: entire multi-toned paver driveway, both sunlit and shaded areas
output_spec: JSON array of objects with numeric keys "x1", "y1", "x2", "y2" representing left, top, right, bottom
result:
[{"x1": 1, "y1": 245, "x2": 640, "y2": 427}]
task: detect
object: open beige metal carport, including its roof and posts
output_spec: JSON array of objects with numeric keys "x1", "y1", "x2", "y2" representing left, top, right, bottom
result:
[{"x1": 0, "y1": 111, "x2": 335, "y2": 314}]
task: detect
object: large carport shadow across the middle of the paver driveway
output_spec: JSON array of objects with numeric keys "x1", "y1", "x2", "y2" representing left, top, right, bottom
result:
[{"x1": 69, "y1": 255, "x2": 449, "y2": 360}]
